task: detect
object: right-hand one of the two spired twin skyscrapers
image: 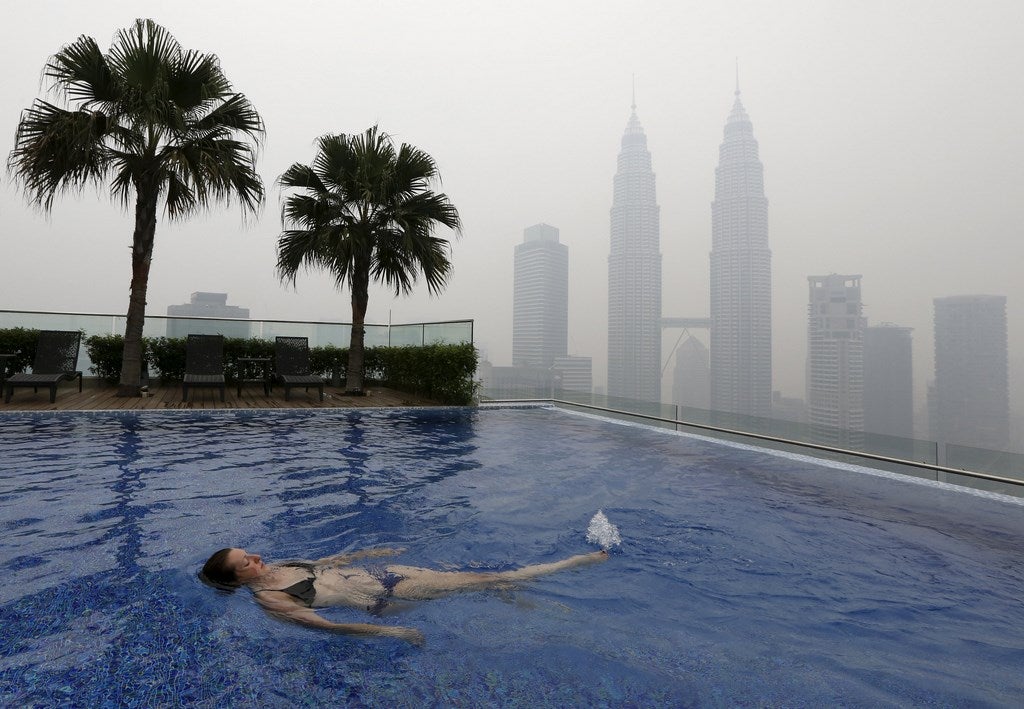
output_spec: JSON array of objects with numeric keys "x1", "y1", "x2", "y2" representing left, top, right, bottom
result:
[{"x1": 711, "y1": 85, "x2": 772, "y2": 416}]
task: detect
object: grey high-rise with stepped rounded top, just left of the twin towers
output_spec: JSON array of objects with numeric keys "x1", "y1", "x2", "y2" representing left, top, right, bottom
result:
[{"x1": 512, "y1": 224, "x2": 569, "y2": 367}]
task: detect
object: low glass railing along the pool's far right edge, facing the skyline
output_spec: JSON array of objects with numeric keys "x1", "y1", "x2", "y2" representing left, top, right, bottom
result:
[{"x1": 480, "y1": 387, "x2": 1024, "y2": 495}]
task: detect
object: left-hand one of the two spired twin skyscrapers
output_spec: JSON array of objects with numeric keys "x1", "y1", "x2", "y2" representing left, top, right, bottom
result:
[{"x1": 608, "y1": 98, "x2": 662, "y2": 402}]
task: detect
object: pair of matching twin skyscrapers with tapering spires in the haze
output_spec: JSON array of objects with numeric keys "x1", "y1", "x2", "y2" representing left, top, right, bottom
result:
[{"x1": 608, "y1": 87, "x2": 771, "y2": 416}]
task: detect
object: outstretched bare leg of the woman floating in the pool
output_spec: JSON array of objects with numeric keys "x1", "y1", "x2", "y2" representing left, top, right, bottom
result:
[{"x1": 387, "y1": 551, "x2": 608, "y2": 600}]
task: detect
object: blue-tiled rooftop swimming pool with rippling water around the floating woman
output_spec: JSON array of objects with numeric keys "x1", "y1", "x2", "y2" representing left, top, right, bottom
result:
[{"x1": 0, "y1": 408, "x2": 1024, "y2": 707}]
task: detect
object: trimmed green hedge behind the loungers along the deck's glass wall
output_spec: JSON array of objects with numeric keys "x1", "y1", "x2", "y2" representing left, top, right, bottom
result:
[{"x1": 81, "y1": 330, "x2": 478, "y2": 406}]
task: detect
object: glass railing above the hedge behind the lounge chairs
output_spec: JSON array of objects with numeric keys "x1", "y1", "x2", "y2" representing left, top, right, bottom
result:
[{"x1": 0, "y1": 310, "x2": 473, "y2": 375}]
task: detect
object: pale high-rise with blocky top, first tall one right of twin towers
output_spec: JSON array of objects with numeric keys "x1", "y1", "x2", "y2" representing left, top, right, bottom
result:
[{"x1": 807, "y1": 274, "x2": 865, "y2": 450}]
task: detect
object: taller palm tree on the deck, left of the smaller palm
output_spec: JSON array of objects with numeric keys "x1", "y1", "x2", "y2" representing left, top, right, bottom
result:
[{"x1": 7, "y1": 19, "x2": 263, "y2": 397}]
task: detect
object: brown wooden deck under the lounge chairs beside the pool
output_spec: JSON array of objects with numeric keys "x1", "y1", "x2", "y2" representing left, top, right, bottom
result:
[{"x1": 0, "y1": 379, "x2": 438, "y2": 413}]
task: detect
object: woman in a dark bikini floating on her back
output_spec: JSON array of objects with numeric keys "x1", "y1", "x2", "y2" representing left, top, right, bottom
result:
[{"x1": 201, "y1": 548, "x2": 608, "y2": 644}]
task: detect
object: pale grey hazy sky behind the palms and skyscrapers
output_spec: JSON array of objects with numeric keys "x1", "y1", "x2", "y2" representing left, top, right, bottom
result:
[{"x1": 0, "y1": 0, "x2": 1024, "y2": 407}]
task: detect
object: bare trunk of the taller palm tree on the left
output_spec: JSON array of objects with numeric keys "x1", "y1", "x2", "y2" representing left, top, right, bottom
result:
[{"x1": 118, "y1": 182, "x2": 158, "y2": 397}]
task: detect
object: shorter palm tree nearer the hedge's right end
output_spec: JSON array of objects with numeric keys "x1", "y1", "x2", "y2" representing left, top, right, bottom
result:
[{"x1": 278, "y1": 126, "x2": 462, "y2": 394}]
